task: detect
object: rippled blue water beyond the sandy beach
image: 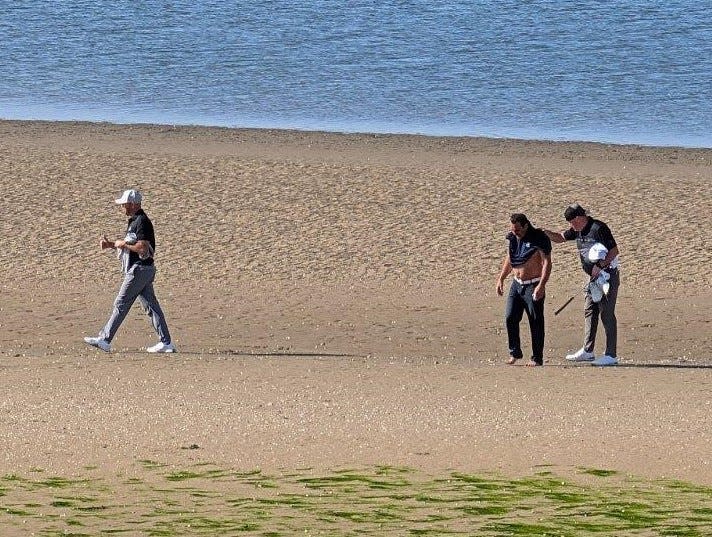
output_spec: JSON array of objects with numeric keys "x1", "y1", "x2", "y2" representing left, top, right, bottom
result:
[{"x1": 0, "y1": 0, "x2": 712, "y2": 147}]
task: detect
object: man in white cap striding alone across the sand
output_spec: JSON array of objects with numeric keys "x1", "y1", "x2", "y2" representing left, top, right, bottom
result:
[{"x1": 84, "y1": 190, "x2": 176, "y2": 352}]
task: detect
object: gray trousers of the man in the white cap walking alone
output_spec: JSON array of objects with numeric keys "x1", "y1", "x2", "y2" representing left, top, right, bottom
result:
[{"x1": 99, "y1": 265, "x2": 171, "y2": 345}]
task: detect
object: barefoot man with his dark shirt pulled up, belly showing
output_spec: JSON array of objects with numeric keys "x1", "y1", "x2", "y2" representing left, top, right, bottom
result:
[{"x1": 497, "y1": 213, "x2": 551, "y2": 366}]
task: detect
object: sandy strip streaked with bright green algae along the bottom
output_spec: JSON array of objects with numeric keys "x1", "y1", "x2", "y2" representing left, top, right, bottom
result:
[{"x1": 0, "y1": 460, "x2": 712, "y2": 537}]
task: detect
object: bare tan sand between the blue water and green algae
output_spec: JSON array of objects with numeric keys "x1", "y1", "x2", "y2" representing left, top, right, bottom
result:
[{"x1": 0, "y1": 122, "x2": 712, "y2": 484}]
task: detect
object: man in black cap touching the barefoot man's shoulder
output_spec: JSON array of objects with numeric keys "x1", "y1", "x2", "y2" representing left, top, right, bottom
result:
[{"x1": 544, "y1": 203, "x2": 620, "y2": 366}]
